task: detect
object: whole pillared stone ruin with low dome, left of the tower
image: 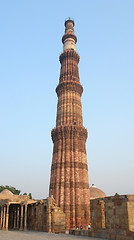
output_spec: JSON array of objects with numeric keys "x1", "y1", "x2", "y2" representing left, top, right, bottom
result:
[{"x1": 0, "y1": 190, "x2": 65, "y2": 233}]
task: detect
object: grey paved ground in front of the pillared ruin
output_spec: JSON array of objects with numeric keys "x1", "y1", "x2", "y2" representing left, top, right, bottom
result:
[{"x1": 0, "y1": 230, "x2": 105, "y2": 240}]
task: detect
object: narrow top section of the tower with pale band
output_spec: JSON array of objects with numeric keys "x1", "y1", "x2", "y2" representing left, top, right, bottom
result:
[{"x1": 62, "y1": 18, "x2": 77, "y2": 51}]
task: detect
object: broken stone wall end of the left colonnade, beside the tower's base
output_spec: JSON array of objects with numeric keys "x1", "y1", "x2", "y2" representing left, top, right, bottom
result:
[{"x1": 27, "y1": 198, "x2": 66, "y2": 233}]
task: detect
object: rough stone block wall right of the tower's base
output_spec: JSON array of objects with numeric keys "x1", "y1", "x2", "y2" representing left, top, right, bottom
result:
[{"x1": 70, "y1": 195, "x2": 134, "y2": 240}]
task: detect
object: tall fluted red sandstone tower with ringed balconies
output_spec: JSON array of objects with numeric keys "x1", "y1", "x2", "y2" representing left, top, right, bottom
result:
[{"x1": 49, "y1": 19, "x2": 90, "y2": 229}]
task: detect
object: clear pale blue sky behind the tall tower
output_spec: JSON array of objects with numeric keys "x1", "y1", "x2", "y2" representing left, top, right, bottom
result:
[{"x1": 0, "y1": 0, "x2": 134, "y2": 198}]
